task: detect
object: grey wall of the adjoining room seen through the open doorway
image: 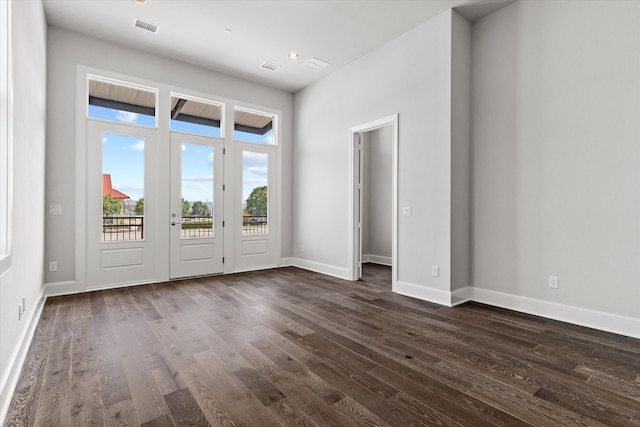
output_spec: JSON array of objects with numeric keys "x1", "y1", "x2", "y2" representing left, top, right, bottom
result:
[{"x1": 362, "y1": 126, "x2": 393, "y2": 265}]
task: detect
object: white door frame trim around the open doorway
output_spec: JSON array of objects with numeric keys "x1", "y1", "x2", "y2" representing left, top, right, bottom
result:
[{"x1": 348, "y1": 114, "x2": 398, "y2": 291}]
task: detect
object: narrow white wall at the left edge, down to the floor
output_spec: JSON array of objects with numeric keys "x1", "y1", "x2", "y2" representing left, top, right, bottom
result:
[{"x1": 0, "y1": 1, "x2": 47, "y2": 424}]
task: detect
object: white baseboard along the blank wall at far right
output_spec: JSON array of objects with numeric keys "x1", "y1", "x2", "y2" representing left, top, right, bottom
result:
[{"x1": 471, "y1": 287, "x2": 640, "y2": 338}]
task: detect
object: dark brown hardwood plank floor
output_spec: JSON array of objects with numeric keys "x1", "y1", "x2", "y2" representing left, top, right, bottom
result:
[{"x1": 4, "y1": 265, "x2": 640, "y2": 427}]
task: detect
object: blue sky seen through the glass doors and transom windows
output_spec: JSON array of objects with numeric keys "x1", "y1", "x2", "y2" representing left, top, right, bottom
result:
[{"x1": 89, "y1": 106, "x2": 271, "y2": 202}]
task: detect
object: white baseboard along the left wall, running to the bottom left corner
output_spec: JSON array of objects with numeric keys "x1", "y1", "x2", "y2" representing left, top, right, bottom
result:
[{"x1": 0, "y1": 289, "x2": 46, "y2": 425}]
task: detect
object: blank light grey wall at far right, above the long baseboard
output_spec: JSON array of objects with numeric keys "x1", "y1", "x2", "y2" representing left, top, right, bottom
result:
[{"x1": 472, "y1": 0, "x2": 640, "y2": 320}]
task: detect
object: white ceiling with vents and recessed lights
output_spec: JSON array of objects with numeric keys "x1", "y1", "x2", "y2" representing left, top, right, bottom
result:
[{"x1": 43, "y1": 0, "x2": 513, "y2": 92}]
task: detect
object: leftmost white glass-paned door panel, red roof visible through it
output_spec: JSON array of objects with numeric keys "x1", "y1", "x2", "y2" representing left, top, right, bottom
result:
[{"x1": 86, "y1": 120, "x2": 157, "y2": 289}]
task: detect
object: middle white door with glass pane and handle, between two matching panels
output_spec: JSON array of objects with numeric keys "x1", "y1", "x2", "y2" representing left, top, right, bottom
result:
[{"x1": 167, "y1": 132, "x2": 223, "y2": 279}]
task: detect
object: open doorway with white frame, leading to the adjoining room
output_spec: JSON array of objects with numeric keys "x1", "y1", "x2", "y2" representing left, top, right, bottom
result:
[{"x1": 351, "y1": 115, "x2": 398, "y2": 289}]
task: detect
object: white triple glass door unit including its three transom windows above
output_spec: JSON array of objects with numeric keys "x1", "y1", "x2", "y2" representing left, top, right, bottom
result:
[{"x1": 82, "y1": 73, "x2": 280, "y2": 289}]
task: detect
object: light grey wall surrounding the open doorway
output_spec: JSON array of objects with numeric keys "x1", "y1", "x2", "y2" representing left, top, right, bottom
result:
[{"x1": 294, "y1": 11, "x2": 468, "y2": 300}]
